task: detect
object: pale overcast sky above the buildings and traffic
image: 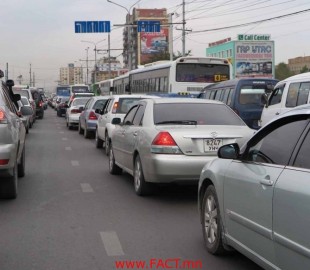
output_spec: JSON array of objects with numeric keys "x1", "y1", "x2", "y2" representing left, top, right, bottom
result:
[{"x1": 0, "y1": 0, "x2": 310, "y2": 90}]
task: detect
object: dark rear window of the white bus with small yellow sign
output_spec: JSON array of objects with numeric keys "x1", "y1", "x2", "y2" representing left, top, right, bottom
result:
[{"x1": 176, "y1": 63, "x2": 230, "y2": 83}]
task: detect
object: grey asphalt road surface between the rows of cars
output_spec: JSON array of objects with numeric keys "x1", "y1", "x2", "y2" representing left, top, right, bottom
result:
[{"x1": 0, "y1": 108, "x2": 261, "y2": 270}]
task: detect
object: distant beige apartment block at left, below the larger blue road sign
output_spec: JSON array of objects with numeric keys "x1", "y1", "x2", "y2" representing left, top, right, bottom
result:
[{"x1": 59, "y1": 64, "x2": 83, "y2": 85}]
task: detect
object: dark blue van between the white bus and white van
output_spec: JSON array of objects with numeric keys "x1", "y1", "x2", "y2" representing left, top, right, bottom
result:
[{"x1": 199, "y1": 78, "x2": 278, "y2": 129}]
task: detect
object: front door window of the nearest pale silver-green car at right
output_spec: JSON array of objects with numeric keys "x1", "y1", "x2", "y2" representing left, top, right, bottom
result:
[{"x1": 245, "y1": 120, "x2": 308, "y2": 165}]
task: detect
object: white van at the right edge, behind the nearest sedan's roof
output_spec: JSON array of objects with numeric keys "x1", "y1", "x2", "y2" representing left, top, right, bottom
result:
[{"x1": 259, "y1": 72, "x2": 310, "y2": 126}]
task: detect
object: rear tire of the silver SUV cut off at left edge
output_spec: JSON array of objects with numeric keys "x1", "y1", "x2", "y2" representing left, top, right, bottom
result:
[{"x1": 0, "y1": 161, "x2": 18, "y2": 200}]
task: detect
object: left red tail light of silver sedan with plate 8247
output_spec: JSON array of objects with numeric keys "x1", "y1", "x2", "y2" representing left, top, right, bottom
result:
[{"x1": 151, "y1": 131, "x2": 182, "y2": 154}]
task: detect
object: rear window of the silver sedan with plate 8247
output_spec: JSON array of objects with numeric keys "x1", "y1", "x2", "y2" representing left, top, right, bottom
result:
[{"x1": 154, "y1": 103, "x2": 245, "y2": 126}]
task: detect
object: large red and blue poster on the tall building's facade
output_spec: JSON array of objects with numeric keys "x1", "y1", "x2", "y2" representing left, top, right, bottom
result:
[{"x1": 140, "y1": 29, "x2": 169, "y2": 64}]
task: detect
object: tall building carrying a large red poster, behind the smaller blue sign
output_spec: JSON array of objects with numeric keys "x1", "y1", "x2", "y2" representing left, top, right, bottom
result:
[{"x1": 123, "y1": 8, "x2": 170, "y2": 70}]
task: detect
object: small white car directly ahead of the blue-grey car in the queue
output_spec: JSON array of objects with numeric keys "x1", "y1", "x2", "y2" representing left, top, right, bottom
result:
[{"x1": 66, "y1": 97, "x2": 90, "y2": 129}]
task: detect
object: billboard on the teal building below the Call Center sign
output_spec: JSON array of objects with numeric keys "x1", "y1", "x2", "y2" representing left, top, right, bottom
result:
[{"x1": 235, "y1": 41, "x2": 274, "y2": 78}]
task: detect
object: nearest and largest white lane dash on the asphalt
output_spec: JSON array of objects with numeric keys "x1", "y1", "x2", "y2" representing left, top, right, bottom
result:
[{"x1": 100, "y1": 231, "x2": 125, "y2": 256}]
